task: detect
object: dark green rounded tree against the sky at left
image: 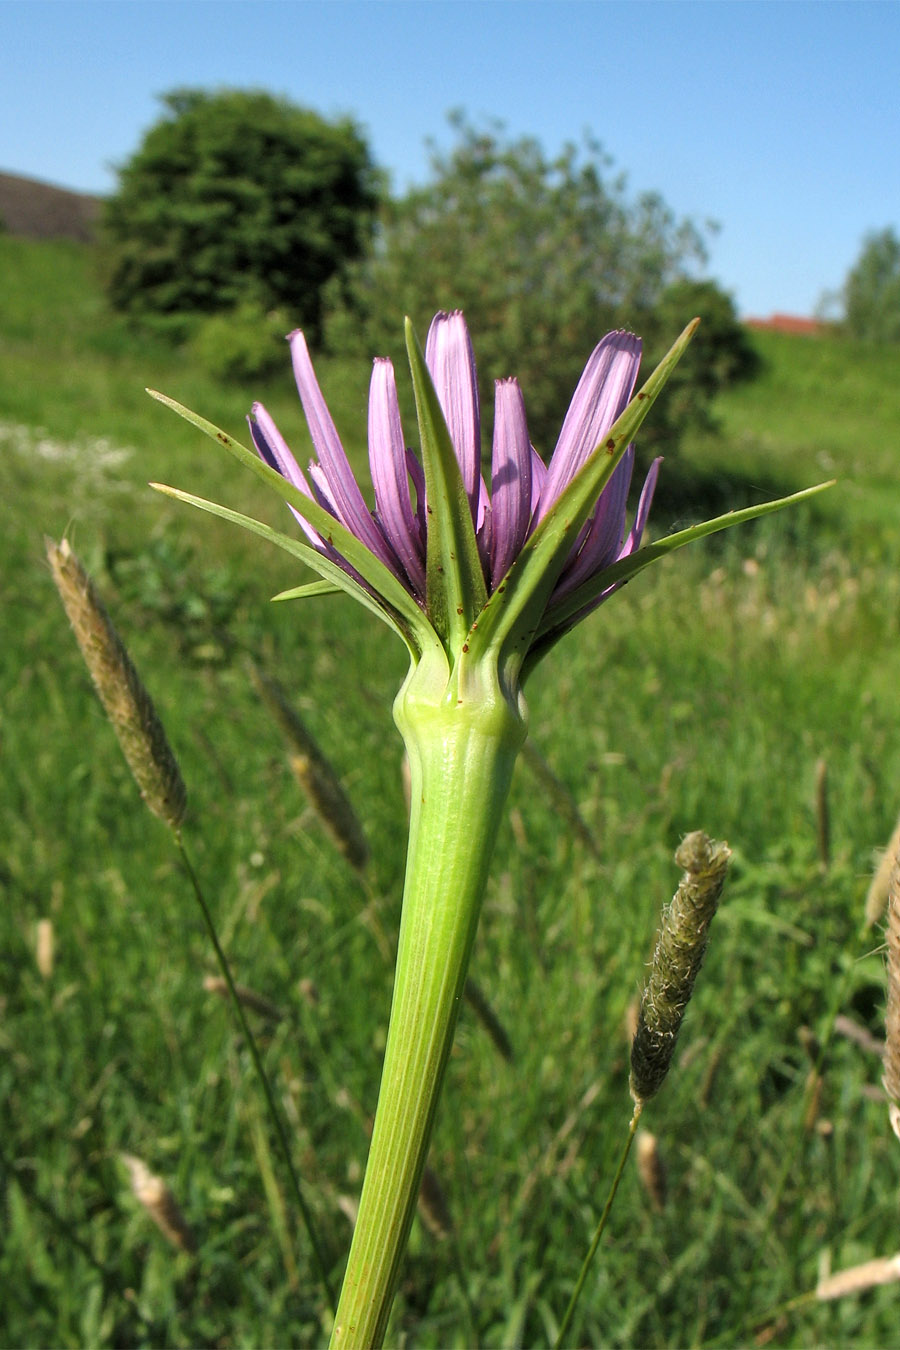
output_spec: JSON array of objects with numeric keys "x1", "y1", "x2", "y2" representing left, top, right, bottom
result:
[{"x1": 104, "y1": 89, "x2": 378, "y2": 342}]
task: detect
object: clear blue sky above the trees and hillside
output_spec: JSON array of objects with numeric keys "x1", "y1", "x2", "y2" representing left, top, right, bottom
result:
[{"x1": 0, "y1": 0, "x2": 900, "y2": 315}]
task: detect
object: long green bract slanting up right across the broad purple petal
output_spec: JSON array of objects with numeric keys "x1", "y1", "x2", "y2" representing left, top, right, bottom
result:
[{"x1": 468, "y1": 319, "x2": 699, "y2": 675}]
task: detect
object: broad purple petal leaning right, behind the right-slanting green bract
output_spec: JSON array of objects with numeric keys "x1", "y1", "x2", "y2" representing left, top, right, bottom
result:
[{"x1": 534, "y1": 332, "x2": 641, "y2": 524}]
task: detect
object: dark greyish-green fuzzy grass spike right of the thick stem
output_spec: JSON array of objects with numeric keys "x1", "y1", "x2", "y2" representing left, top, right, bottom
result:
[{"x1": 630, "y1": 830, "x2": 731, "y2": 1102}]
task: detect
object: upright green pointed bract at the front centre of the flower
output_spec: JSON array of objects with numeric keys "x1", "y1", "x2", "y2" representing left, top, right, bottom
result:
[{"x1": 406, "y1": 319, "x2": 487, "y2": 652}]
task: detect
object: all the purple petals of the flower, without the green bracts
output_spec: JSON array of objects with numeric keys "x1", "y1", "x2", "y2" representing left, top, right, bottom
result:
[{"x1": 248, "y1": 311, "x2": 660, "y2": 626}]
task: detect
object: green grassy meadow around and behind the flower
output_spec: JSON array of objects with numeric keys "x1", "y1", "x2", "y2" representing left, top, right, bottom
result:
[{"x1": 0, "y1": 238, "x2": 900, "y2": 1347}]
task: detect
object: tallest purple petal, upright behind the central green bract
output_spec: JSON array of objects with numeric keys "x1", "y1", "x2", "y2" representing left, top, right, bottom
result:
[{"x1": 425, "y1": 309, "x2": 483, "y2": 528}]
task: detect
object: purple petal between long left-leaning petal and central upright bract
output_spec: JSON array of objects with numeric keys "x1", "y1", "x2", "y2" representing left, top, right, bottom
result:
[{"x1": 368, "y1": 358, "x2": 425, "y2": 595}]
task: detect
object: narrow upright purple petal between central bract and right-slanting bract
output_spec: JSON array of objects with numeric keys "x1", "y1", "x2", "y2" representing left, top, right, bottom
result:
[{"x1": 491, "y1": 379, "x2": 532, "y2": 583}]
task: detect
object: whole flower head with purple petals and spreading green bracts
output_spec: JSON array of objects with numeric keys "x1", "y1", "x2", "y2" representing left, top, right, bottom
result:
[{"x1": 148, "y1": 313, "x2": 830, "y2": 675}]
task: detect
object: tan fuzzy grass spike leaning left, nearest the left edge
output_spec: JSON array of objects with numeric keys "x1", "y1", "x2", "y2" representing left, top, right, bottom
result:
[{"x1": 46, "y1": 539, "x2": 188, "y2": 830}]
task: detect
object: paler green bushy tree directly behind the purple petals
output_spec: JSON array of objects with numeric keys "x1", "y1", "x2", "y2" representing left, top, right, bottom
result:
[{"x1": 325, "y1": 115, "x2": 749, "y2": 452}]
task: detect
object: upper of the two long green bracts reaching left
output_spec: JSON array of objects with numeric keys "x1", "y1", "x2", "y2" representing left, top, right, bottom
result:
[{"x1": 147, "y1": 389, "x2": 433, "y2": 651}]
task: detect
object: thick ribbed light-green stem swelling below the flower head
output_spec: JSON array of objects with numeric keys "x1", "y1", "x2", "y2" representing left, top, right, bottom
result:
[{"x1": 332, "y1": 648, "x2": 525, "y2": 1350}]
